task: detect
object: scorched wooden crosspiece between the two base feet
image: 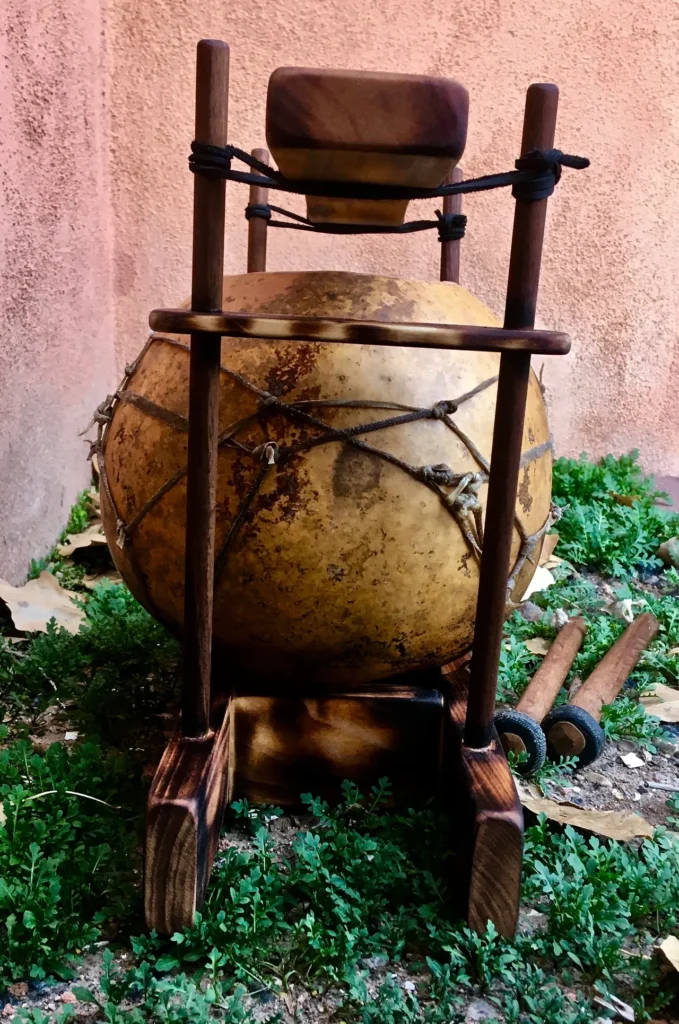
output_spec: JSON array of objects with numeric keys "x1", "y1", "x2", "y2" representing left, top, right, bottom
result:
[{"x1": 229, "y1": 674, "x2": 443, "y2": 807}]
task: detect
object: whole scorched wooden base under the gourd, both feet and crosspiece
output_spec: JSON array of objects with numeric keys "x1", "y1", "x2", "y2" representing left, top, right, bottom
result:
[{"x1": 144, "y1": 668, "x2": 523, "y2": 936}]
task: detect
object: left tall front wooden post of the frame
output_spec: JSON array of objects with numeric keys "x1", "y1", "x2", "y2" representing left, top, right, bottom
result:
[{"x1": 181, "y1": 39, "x2": 229, "y2": 737}]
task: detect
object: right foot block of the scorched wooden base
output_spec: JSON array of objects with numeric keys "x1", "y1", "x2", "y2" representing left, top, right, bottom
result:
[{"x1": 441, "y1": 669, "x2": 523, "y2": 937}]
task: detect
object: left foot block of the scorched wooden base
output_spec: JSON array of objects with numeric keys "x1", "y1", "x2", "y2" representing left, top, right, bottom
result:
[{"x1": 144, "y1": 700, "x2": 230, "y2": 935}]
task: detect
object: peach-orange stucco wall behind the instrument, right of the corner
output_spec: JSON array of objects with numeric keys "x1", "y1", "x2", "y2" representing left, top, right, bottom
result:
[{"x1": 111, "y1": 0, "x2": 679, "y2": 473}]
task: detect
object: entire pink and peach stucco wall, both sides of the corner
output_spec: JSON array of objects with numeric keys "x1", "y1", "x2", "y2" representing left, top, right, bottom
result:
[{"x1": 0, "y1": 0, "x2": 679, "y2": 574}]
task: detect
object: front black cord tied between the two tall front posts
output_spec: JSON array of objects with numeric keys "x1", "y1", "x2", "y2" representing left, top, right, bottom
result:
[{"x1": 188, "y1": 141, "x2": 590, "y2": 203}]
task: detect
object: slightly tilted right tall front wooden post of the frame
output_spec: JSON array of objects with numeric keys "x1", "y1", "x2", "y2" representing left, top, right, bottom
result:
[{"x1": 464, "y1": 84, "x2": 559, "y2": 749}]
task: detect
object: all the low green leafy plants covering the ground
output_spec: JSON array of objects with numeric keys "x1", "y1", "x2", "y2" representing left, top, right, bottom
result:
[{"x1": 0, "y1": 456, "x2": 679, "y2": 1024}]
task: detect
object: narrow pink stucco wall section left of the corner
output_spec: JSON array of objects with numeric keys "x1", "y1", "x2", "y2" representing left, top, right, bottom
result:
[{"x1": 0, "y1": 0, "x2": 115, "y2": 581}]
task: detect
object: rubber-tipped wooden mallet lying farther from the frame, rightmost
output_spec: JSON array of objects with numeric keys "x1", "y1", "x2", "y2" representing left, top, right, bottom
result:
[{"x1": 543, "y1": 611, "x2": 659, "y2": 768}]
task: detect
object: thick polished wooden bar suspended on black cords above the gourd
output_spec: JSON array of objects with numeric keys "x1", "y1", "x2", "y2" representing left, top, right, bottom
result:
[{"x1": 266, "y1": 68, "x2": 469, "y2": 225}]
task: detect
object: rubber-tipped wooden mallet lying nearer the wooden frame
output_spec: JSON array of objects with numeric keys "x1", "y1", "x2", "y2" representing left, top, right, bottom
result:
[{"x1": 495, "y1": 617, "x2": 587, "y2": 775}]
